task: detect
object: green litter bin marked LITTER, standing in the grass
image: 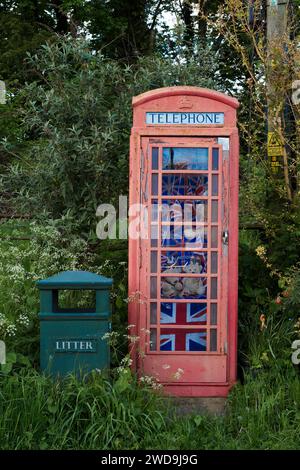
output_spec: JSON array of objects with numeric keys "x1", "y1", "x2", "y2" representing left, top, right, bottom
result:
[{"x1": 37, "y1": 271, "x2": 112, "y2": 377}]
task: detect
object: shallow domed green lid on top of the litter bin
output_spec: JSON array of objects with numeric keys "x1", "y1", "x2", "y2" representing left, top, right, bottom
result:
[{"x1": 37, "y1": 271, "x2": 113, "y2": 289}]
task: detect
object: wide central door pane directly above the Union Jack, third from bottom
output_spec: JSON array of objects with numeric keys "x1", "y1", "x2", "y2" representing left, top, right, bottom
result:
[{"x1": 161, "y1": 276, "x2": 207, "y2": 299}]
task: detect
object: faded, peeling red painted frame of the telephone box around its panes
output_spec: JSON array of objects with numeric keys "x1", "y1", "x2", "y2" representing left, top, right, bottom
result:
[{"x1": 129, "y1": 87, "x2": 239, "y2": 397}]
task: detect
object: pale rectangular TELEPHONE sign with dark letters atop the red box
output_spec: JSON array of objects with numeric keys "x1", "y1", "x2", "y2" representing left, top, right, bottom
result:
[{"x1": 146, "y1": 112, "x2": 224, "y2": 126}]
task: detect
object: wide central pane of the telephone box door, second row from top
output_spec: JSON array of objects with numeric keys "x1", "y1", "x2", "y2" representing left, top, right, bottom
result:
[{"x1": 162, "y1": 173, "x2": 209, "y2": 197}]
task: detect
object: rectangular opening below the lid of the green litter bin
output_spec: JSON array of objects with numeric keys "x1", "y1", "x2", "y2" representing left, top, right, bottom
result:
[{"x1": 53, "y1": 289, "x2": 96, "y2": 313}]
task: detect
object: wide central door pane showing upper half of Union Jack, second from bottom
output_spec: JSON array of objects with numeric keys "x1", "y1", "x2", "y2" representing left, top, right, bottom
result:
[{"x1": 160, "y1": 302, "x2": 207, "y2": 325}]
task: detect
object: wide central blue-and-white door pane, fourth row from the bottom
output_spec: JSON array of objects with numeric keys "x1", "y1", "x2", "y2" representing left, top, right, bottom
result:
[{"x1": 161, "y1": 251, "x2": 207, "y2": 274}]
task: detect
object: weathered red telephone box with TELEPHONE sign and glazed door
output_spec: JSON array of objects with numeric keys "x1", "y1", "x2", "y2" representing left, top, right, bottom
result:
[{"x1": 129, "y1": 86, "x2": 239, "y2": 397}]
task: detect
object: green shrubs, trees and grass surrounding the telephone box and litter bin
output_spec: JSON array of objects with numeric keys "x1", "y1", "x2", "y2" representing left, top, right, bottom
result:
[{"x1": 0, "y1": 4, "x2": 300, "y2": 449}]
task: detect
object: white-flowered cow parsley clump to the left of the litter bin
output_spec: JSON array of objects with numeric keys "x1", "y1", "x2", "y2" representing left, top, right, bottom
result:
[{"x1": 0, "y1": 220, "x2": 92, "y2": 361}]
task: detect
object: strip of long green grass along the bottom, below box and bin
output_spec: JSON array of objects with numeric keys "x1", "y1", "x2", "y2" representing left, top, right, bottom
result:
[{"x1": 0, "y1": 368, "x2": 300, "y2": 450}]
